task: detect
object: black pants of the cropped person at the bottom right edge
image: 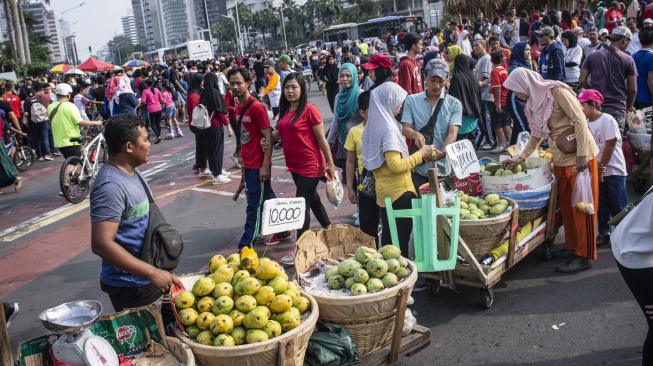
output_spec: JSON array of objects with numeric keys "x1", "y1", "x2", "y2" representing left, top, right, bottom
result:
[{"x1": 617, "y1": 263, "x2": 653, "y2": 366}]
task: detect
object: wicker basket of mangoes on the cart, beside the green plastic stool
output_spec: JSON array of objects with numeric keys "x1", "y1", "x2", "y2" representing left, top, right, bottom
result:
[{"x1": 459, "y1": 197, "x2": 517, "y2": 256}]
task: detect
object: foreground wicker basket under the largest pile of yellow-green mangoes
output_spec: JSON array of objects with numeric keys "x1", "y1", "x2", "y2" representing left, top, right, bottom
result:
[{"x1": 177, "y1": 291, "x2": 319, "y2": 366}]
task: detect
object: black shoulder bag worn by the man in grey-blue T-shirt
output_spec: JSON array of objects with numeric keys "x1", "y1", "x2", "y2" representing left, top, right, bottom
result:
[{"x1": 136, "y1": 173, "x2": 184, "y2": 271}]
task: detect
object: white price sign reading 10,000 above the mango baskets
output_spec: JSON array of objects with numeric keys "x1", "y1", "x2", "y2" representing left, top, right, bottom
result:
[{"x1": 261, "y1": 197, "x2": 306, "y2": 235}]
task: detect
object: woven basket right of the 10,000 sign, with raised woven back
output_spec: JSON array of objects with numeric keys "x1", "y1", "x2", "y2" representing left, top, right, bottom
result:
[{"x1": 295, "y1": 225, "x2": 417, "y2": 357}]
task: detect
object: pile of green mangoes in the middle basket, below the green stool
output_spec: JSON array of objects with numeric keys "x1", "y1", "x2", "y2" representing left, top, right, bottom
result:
[{"x1": 325, "y1": 245, "x2": 410, "y2": 296}]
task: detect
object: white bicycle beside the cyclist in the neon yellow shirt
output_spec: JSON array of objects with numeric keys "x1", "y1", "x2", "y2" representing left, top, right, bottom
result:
[{"x1": 59, "y1": 129, "x2": 107, "y2": 203}]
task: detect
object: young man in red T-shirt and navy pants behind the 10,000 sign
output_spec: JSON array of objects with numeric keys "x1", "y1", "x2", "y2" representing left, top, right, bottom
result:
[{"x1": 228, "y1": 68, "x2": 290, "y2": 248}]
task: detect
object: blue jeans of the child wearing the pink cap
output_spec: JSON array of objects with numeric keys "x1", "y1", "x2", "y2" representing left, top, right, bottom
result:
[{"x1": 599, "y1": 175, "x2": 628, "y2": 236}]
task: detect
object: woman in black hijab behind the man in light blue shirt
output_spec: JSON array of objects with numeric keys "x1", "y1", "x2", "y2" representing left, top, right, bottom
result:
[{"x1": 449, "y1": 55, "x2": 481, "y2": 140}]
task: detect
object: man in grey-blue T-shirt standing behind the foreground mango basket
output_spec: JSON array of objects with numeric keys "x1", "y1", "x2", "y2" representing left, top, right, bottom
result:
[{"x1": 91, "y1": 114, "x2": 182, "y2": 311}]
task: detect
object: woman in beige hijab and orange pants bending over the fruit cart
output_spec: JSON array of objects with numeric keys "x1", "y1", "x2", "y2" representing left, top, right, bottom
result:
[{"x1": 504, "y1": 68, "x2": 599, "y2": 273}]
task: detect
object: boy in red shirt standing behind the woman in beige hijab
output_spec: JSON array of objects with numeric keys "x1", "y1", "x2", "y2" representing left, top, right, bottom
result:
[{"x1": 490, "y1": 51, "x2": 512, "y2": 153}]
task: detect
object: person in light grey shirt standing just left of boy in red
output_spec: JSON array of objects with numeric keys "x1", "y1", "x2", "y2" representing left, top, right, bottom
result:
[{"x1": 472, "y1": 39, "x2": 496, "y2": 150}]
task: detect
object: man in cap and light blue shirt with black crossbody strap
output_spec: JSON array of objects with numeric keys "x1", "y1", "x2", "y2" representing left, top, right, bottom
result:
[{"x1": 401, "y1": 59, "x2": 463, "y2": 188}]
